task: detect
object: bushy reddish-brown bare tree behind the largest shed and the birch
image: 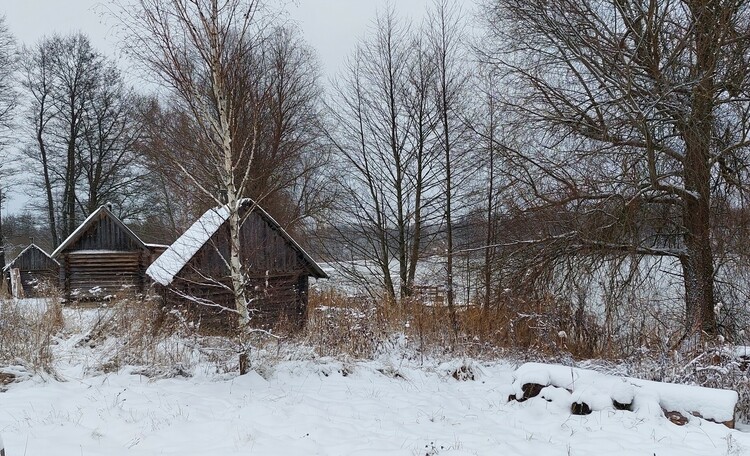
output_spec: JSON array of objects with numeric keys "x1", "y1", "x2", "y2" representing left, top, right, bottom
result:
[{"x1": 139, "y1": 22, "x2": 331, "y2": 239}]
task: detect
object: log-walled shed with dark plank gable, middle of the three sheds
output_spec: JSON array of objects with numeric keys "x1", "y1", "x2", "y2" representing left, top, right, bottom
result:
[{"x1": 52, "y1": 206, "x2": 164, "y2": 301}]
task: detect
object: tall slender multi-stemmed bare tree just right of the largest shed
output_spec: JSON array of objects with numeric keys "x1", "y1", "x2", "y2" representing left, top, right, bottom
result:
[{"x1": 329, "y1": 9, "x2": 437, "y2": 301}]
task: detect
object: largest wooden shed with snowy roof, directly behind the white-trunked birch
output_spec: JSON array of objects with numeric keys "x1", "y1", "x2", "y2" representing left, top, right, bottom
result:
[{"x1": 147, "y1": 199, "x2": 328, "y2": 328}]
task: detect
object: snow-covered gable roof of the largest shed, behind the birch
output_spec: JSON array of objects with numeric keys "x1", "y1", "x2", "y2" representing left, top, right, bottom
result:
[{"x1": 146, "y1": 198, "x2": 328, "y2": 286}]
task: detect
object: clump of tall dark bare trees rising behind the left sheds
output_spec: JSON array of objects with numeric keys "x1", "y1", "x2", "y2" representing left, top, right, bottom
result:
[{"x1": 21, "y1": 34, "x2": 148, "y2": 246}]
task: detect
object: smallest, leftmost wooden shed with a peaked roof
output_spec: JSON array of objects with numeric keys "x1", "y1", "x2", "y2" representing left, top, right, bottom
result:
[{"x1": 3, "y1": 242, "x2": 60, "y2": 298}]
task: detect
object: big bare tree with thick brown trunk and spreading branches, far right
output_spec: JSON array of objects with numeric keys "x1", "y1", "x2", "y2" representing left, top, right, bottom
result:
[{"x1": 485, "y1": 0, "x2": 750, "y2": 334}]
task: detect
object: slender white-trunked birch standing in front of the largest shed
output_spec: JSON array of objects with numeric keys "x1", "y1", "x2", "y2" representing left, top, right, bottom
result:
[{"x1": 121, "y1": 0, "x2": 266, "y2": 328}]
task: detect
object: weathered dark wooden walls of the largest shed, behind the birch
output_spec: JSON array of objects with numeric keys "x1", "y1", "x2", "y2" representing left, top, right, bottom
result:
[{"x1": 157, "y1": 201, "x2": 319, "y2": 329}]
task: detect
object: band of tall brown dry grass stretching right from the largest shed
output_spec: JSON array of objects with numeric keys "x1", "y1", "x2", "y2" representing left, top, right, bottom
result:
[{"x1": 306, "y1": 292, "x2": 700, "y2": 359}]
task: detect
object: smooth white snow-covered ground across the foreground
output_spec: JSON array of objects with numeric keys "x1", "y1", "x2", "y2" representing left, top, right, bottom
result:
[{"x1": 0, "y1": 302, "x2": 750, "y2": 456}]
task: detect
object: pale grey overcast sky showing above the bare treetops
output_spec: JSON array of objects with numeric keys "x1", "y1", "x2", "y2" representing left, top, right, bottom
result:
[{"x1": 0, "y1": 0, "x2": 432, "y2": 212}]
